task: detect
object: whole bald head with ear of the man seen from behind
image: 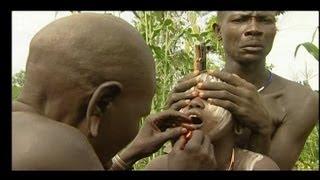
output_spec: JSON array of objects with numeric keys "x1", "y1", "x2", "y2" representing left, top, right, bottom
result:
[{"x1": 16, "y1": 13, "x2": 156, "y2": 165}]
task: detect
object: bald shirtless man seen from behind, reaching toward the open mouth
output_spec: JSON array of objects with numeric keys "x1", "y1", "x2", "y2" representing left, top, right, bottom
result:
[{"x1": 12, "y1": 13, "x2": 218, "y2": 170}]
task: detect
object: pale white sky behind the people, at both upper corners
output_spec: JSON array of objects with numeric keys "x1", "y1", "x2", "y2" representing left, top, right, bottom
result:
[{"x1": 12, "y1": 11, "x2": 319, "y2": 90}]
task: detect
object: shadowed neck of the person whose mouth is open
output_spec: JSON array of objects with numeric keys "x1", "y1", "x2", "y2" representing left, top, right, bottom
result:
[{"x1": 213, "y1": 133, "x2": 234, "y2": 170}]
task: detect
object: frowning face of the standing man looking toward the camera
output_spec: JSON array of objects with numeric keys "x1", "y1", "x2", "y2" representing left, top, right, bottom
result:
[{"x1": 218, "y1": 11, "x2": 276, "y2": 63}]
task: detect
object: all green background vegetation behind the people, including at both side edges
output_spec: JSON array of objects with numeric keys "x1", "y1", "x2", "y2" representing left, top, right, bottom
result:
[{"x1": 12, "y1": 11, "x2": 319, "y2": 170}]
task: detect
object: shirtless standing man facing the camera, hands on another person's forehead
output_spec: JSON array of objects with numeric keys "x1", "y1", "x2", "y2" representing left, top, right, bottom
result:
[{"x1": 168, "y1": 11, "x2": 319, "y2": 170}]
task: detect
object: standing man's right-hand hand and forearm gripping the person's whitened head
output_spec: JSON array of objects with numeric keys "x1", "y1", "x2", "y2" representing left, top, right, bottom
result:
[{"x1": 197, "y1": 71, "x2": 274, "y2": 155}]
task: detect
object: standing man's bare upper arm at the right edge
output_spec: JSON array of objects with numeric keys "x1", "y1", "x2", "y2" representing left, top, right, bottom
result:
[{"x1": 269, "y1": 93, "x2": 319, "y2": 169}]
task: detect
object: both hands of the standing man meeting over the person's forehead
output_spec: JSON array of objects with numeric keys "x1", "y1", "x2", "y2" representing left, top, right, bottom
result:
[{"x1": 167, "y1": 71, "x2": 273, "y2": 154}]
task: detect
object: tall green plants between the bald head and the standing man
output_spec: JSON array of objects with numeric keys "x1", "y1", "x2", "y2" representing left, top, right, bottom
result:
[{"x1": 134, "y1": 11, "x2": 222, "y2": 169}]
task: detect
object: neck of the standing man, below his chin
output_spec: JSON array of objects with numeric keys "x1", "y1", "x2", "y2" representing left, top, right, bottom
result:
[{"x1": 224, "y1": 57, "x2": 269, "y2": 88}]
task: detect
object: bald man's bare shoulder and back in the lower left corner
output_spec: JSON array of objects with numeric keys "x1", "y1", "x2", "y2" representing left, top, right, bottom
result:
[{"x1": 12, "y1": 112, "x2": 102, "y2": 170}]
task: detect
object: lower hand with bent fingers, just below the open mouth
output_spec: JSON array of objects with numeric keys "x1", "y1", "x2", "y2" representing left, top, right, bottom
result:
[{"x1": 167, "y1": 130, "x2": 217, "y2": 170}]
